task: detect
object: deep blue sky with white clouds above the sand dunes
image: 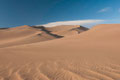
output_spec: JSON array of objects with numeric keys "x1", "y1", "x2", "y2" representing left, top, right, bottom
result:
[{"x1": 0, "y1": 0, "x2": 120, "y2": 27}]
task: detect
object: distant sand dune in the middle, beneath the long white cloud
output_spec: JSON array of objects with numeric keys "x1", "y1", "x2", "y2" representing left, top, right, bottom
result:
[{"x1": 47, "y1": 25, "x2": 88, "y2": 37}]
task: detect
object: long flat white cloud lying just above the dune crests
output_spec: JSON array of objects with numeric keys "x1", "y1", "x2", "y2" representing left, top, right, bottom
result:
[{"x1": 37, "y1": 20, "x2": 104, "y2": 27}]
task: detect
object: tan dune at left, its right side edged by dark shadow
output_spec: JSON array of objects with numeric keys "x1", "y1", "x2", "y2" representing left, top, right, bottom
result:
[{"x1": 0, "y1": 25, "x2": 55, "y2": 47}]
